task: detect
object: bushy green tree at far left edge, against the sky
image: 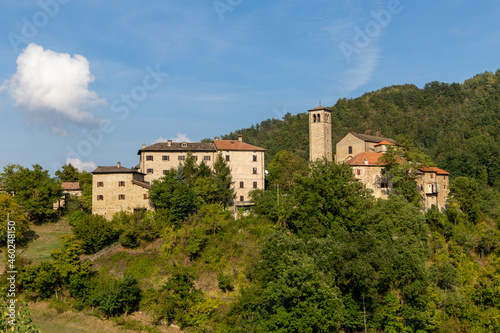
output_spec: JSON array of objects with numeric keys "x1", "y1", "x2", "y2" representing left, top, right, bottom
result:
[{"x1": 0, "y1": 164, "x2": 62, "y2": 223}]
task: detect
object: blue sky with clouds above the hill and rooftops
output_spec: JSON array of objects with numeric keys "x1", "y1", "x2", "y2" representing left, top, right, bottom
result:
[{"x1": 0, "y1": 0, "x2": 500, "y2": 173}]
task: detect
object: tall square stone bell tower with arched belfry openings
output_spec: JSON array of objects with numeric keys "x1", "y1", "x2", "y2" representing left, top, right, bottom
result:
[{"x1": 308, "y1": 105, "x2": 332, "y2": 161}]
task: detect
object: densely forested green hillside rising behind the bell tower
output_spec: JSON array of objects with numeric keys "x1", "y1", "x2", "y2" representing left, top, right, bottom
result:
[{"x1": 223, "y1": 70, "x2": 500, "y2": 188}]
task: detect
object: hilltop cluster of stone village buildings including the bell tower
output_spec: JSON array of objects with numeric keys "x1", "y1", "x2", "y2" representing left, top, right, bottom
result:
[{"x1": 92, "y1": 105, "x2": 449, "y2": 219}]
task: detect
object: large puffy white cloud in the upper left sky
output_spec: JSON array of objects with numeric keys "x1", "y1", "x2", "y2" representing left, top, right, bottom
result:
[{"x1": 4, "y1": 43, "x2": 106, "y2": 135}]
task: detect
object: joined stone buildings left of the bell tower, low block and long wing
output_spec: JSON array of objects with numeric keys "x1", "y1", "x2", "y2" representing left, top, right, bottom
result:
[{"x1": 92, "y1": 135, "x2": 265, "y2": 219}]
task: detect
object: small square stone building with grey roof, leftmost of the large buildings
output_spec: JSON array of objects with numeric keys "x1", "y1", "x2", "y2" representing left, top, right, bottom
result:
[{"x1": 92, "y1": 162, "x2": 152, "y2": 220}]
